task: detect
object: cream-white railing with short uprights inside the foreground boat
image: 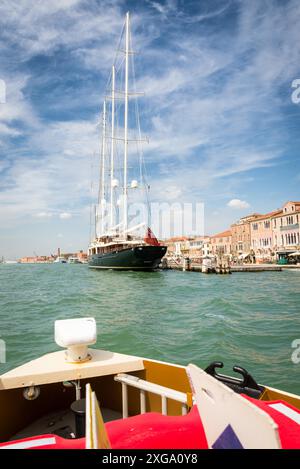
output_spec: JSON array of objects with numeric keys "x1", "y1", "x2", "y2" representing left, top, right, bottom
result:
[{"x1": 114, "y1": 373, "x2": 188, "y2": 419}]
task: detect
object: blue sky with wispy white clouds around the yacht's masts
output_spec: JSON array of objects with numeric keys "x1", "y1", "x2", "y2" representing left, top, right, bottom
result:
[{"x1": 0, "y1": 0, "x2": 300, "y2": 258}]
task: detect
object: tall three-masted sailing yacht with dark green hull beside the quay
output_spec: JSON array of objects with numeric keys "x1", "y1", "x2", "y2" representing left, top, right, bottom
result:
[{"x1": 88, "y1": 13, "x2": 167, "y2": 270}]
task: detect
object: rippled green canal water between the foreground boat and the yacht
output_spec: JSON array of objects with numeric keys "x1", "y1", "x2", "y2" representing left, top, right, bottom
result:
[{"x1": 0, "y1": 264, "x2": 300, "y2": 394}]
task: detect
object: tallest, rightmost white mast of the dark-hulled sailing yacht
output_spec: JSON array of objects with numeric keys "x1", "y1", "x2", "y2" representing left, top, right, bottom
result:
[{"x1": 123, "y1": 12, "x2": 129, "y2": 236}]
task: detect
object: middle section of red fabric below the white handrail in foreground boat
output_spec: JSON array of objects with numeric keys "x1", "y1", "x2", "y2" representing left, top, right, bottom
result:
[{"x1": 105, "y1": 406, "x2": 208, "y2": 449}]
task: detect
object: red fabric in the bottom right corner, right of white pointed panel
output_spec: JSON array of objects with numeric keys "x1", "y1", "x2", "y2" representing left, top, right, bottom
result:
[{"x1": 242, "y1": 394, "x2": 300, "y2": 449}]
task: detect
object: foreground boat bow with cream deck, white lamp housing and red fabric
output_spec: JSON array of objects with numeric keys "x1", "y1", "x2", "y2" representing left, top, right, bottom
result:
[{"x1": 0, "y1": 318, "x2": 300, "y2": 449}]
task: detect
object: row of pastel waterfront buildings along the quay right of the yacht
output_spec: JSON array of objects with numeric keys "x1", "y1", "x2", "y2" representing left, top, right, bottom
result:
[{"x1": 165, "y1": 201, "x2": 300, "y2": 263}]
